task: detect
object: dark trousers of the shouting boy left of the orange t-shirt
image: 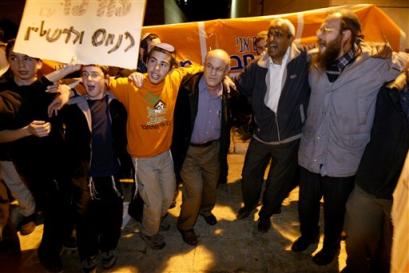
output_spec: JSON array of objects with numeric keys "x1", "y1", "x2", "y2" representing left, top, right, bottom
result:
[{"x1": 73, "y1": 177, "x2": 123, "y2": 260}]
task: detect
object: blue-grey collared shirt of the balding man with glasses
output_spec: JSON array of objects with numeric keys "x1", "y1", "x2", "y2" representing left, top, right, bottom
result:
[{"x1": 190, "y1": 77, "x2": 223, "y2": 144}]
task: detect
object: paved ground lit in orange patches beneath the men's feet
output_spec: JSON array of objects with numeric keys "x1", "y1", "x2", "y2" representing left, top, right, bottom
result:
[{"x1": 11, "y1": 135, "x2": 345, "y2": 273}]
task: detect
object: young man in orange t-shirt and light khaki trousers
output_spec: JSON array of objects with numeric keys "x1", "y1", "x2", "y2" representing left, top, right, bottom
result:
[{"x1": 108, "y1": 43, "x2": 201, "y2": 249}]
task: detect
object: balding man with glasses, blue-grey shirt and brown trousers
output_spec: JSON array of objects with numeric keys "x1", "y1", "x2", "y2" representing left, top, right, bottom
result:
[{"x1": 172, "y1": 49, "x2": 242, "y2": 245}]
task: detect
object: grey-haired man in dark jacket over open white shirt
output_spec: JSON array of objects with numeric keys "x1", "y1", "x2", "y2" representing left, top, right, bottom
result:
[{"x1": 236, "y1": 18, "x2": 310, "y2": 232}]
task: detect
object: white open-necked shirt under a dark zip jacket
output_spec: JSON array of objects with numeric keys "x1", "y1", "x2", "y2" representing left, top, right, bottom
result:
[{"x1": 264, "y1": 48, "x2": 290, "y2": 113}]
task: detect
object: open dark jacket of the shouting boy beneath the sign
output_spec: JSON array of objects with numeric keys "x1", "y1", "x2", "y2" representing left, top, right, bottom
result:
[{"x1": 61, "y1": 94, "x2": 132, "y2": 178}]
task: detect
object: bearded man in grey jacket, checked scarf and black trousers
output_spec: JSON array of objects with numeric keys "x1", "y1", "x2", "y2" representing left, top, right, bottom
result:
[{"x1": 292, "y1": 10, "x2": 407, "y2": 265}]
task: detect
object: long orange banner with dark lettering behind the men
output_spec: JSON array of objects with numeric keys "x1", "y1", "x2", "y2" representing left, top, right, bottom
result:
[{"x1": 142, "y1": 4, "x2": 403, "y2": 76}]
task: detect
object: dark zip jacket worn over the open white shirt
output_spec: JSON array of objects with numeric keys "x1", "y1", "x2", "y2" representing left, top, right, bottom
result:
[{"x1": 236, "y1": 45, "x2": 310, "y2": 144}]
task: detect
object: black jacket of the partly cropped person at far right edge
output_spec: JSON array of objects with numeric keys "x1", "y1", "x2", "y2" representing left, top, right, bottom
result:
[{"x1": 356, "y1": 75, "x2": 409, "y2": 199}]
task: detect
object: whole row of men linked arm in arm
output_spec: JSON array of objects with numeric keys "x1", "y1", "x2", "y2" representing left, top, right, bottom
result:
[{"x1": 0, "y1": 7, "x2": 409, "y2": 273}]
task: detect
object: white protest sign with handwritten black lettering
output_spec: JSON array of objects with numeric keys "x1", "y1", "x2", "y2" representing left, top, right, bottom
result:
[{"x1": 14, "y1": 0, "x2": 146, "y2": 69}]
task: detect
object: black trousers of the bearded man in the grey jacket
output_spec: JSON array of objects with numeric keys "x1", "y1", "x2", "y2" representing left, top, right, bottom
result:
[{"x1": 298, "y1": 168, "x2": 355, "y2": 250}]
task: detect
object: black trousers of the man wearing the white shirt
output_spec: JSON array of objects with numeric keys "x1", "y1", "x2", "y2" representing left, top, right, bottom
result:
[{"x1": 241, "y1": 138, "x2": 299, "y2": 217}]
